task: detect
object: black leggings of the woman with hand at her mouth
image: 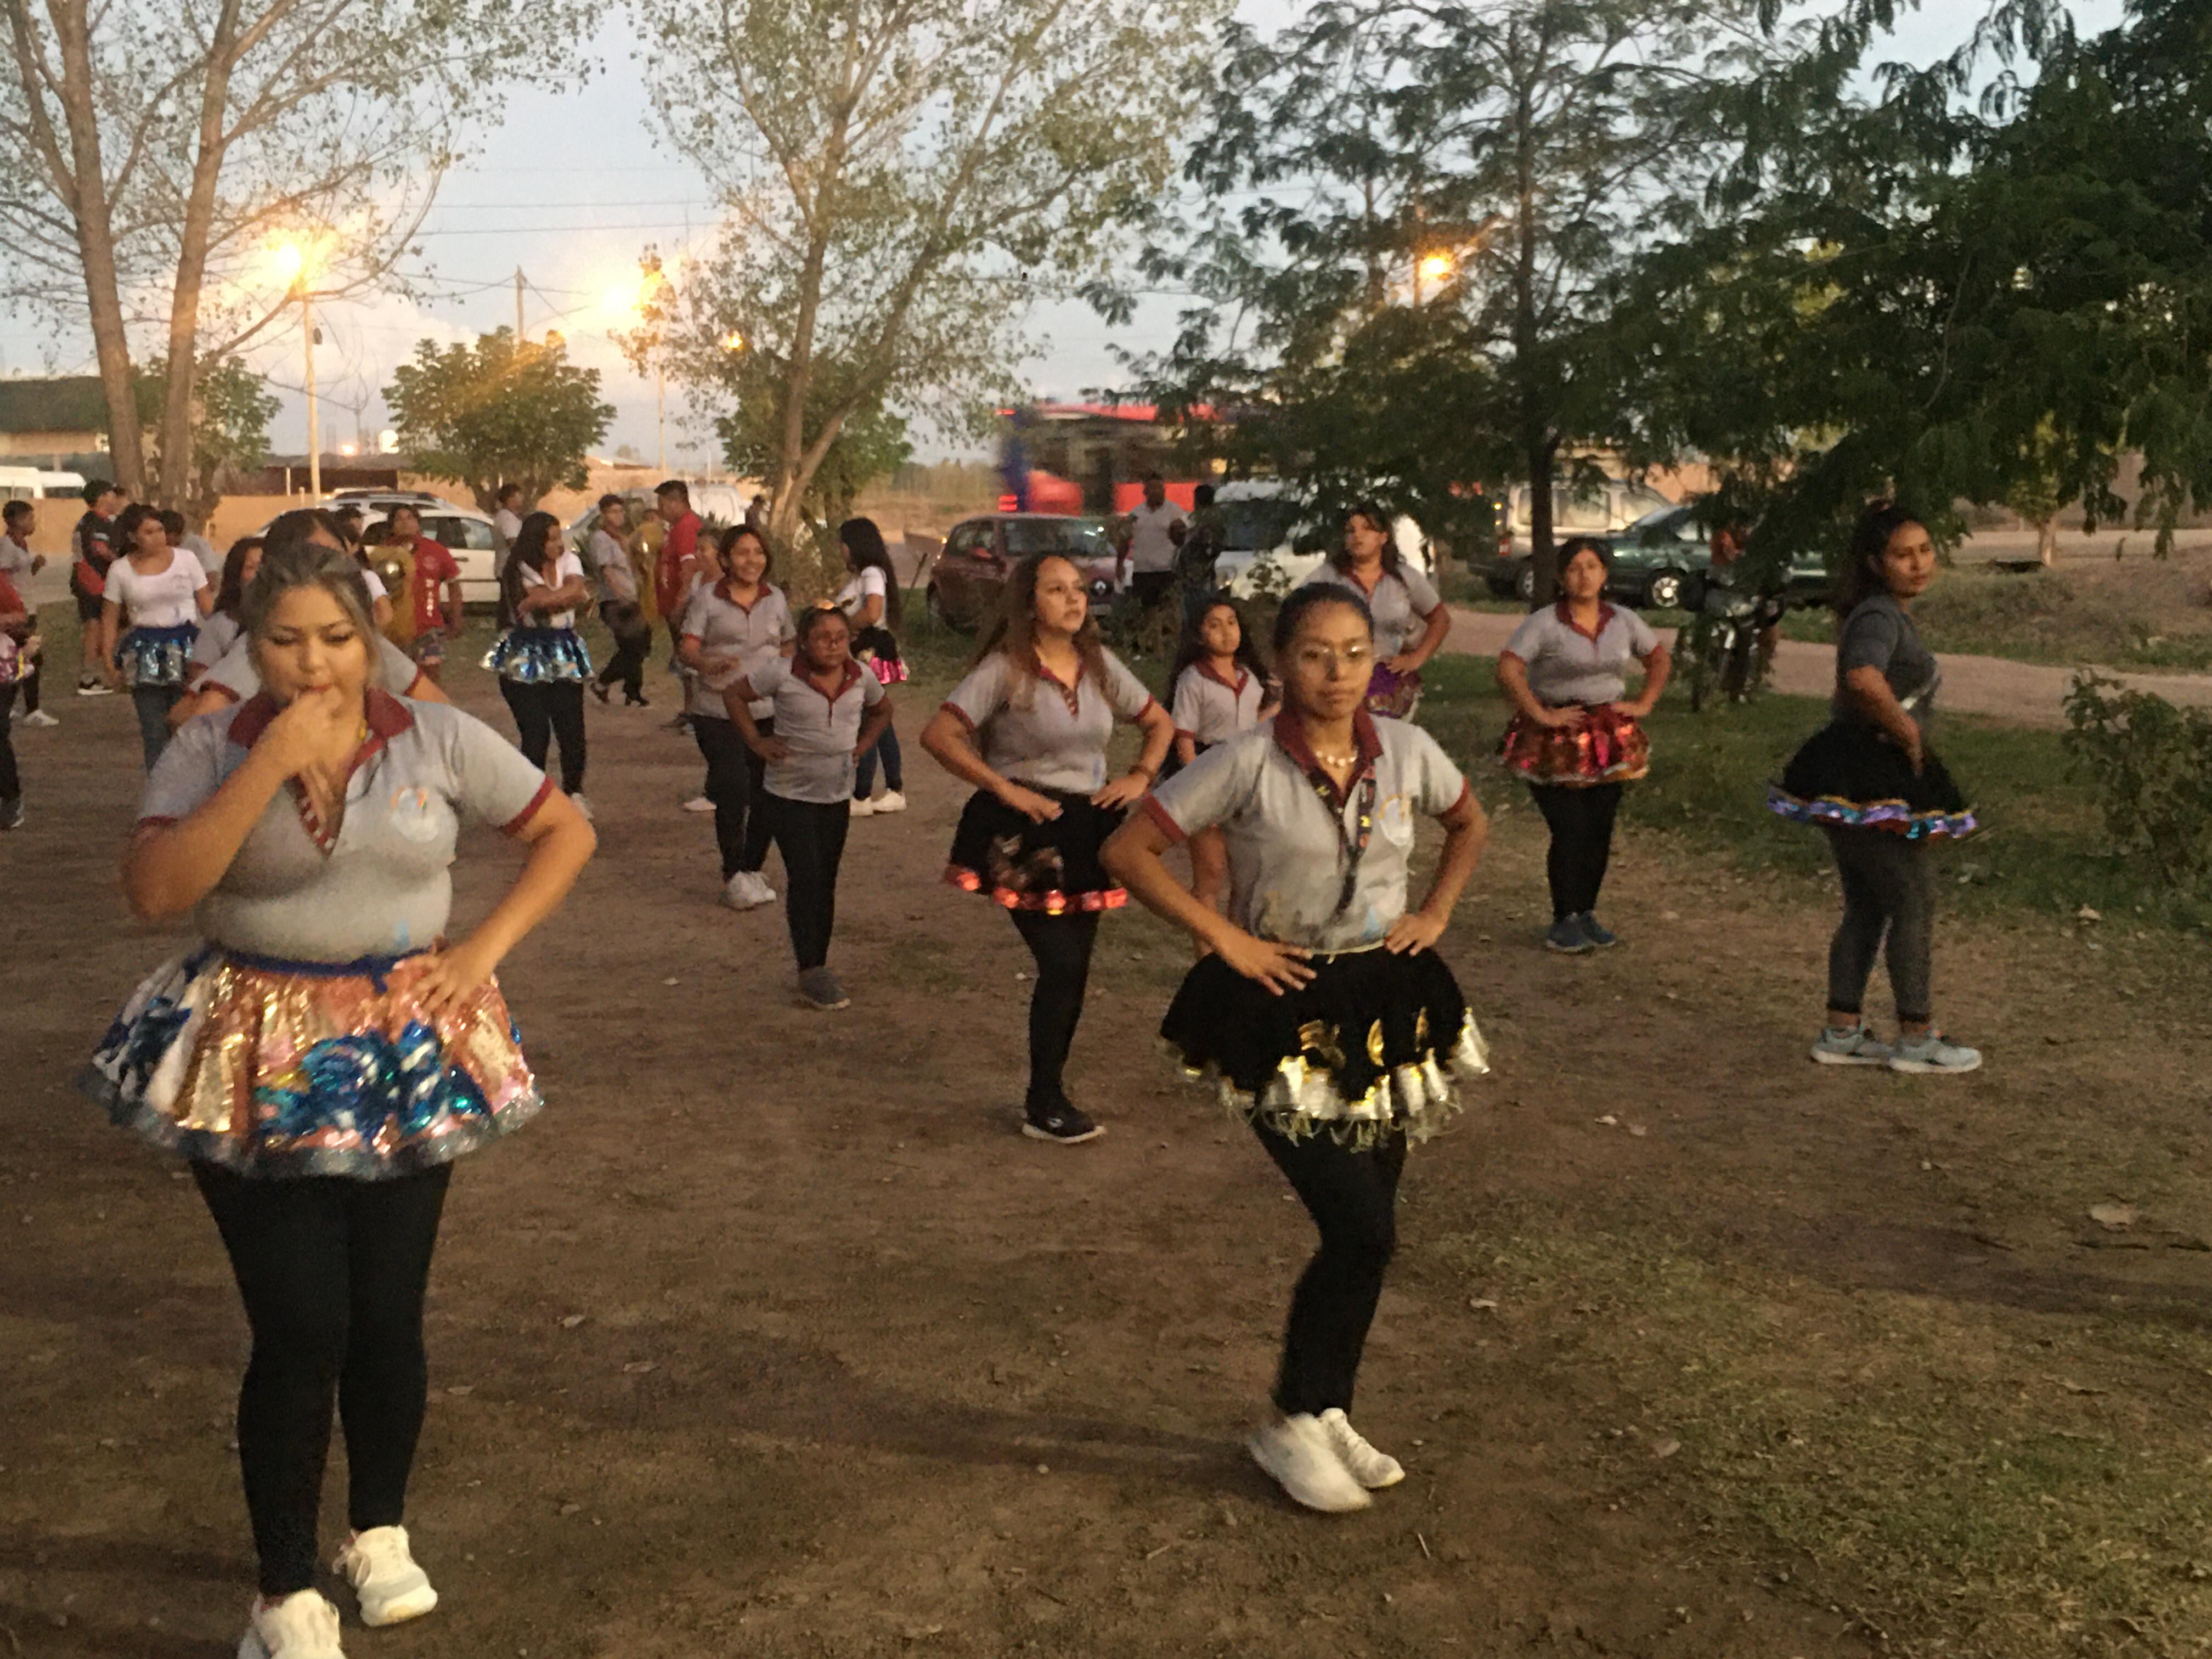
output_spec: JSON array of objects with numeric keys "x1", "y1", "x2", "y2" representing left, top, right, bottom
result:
[{"x1": 193, "y1": 1164, "x2": 454, "y2": 1597}]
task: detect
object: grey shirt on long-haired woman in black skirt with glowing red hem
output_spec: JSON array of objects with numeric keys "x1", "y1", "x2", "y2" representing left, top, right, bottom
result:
[{"x1": 945, "y1": 650, "x2": 1153, "y2": 794}]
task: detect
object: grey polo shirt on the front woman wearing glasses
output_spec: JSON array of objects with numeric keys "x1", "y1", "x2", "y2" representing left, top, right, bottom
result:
[{"x1": 1144, "y1": 710, "x2": 1469, "y2": 951}]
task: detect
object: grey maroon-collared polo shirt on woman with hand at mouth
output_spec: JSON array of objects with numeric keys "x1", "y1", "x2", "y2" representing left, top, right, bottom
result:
[{"x1": 139, "y1": 690, "x2": 553, "y2": 962}]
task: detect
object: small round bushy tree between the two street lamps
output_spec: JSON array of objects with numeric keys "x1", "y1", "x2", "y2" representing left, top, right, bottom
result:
[{"x1": 385, "y1": 328, "x2": 615, "y2": 511}]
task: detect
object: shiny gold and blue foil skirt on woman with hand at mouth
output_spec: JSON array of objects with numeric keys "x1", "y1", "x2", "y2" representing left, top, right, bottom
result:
[{"x1": 82, "y1": 947, "x2": 542, "y2": 1181}]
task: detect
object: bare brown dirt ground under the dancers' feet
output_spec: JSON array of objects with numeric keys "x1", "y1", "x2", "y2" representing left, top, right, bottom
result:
[{"x1": 0, "y1": 681, "x2": 2208, "y2": 1659}]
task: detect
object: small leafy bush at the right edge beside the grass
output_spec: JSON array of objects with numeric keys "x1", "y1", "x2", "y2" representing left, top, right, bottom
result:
[{"x1": 2066, "y1": 673, "x2": 2212, "y2": 891}]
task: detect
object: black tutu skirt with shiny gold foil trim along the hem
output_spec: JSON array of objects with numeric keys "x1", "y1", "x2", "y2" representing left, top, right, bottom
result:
[{"x1": 1159, "y1": 949, "x2": 1491, "y2": 1146}]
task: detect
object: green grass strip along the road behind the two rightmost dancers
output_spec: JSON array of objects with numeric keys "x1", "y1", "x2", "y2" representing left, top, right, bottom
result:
[{"x1": 1420, "y1": 657, "x2": 2212, "y2": 927}]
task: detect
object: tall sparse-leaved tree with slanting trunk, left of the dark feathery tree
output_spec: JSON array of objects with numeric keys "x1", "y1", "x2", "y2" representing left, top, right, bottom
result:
[{"x1": 639, "y1": 0, "x2": 1226, "y2": 579}]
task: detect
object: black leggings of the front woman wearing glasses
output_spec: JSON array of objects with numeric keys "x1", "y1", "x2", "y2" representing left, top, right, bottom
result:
[{"x1": 1254, "y1": 1124, "x2": 1404, "y2": 1415}]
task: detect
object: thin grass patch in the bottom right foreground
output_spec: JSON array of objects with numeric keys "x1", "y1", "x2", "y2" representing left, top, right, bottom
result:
[{"x1": 1425, "y1": 1215, "x2": 2212, "y2": 1659}]
